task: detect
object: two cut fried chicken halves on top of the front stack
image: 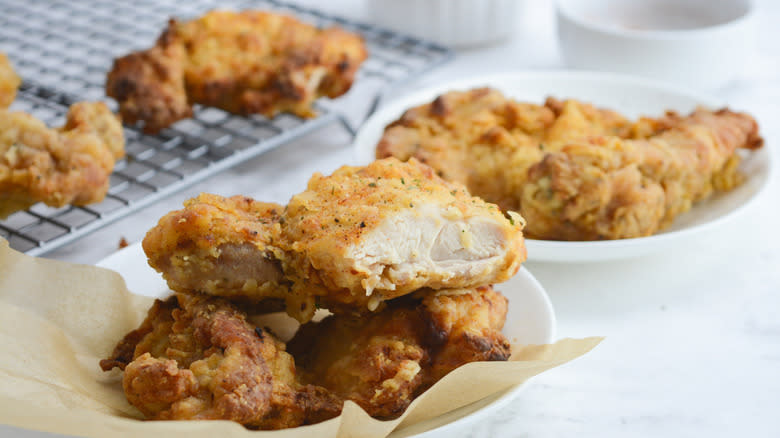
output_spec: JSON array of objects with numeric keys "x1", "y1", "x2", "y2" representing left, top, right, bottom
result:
[{"x1": 143, "y1": 158, "x2": 526, "y2": 322}]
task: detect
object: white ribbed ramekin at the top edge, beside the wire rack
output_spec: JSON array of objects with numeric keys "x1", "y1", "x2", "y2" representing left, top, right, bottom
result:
[{"x1": 367, "y1": 0, "x2": 521, "y2": 47}]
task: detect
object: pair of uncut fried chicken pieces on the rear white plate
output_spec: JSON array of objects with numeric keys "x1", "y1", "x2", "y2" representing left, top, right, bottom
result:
[{"x1": 376, "y1": 88, "x2": 763, "y2": 240}]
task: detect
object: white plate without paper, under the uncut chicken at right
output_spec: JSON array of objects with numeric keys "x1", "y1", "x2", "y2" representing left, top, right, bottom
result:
[{"x1": 354, "y1": 71, "x2": 771, "y2": 262}]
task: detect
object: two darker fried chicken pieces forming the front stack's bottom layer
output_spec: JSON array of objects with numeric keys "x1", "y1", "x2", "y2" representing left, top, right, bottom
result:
[{"x1": 105, "y1": 287, "x2": 509, "y2": 429}]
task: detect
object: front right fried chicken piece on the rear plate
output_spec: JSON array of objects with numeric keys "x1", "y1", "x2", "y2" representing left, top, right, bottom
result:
[{"x1": 521, "y1": 109, "x2": 762, "y2": 240}]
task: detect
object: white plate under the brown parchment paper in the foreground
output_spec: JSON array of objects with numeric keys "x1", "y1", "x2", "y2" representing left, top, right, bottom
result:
[{"x1": 97, "y1": 243, "x2": 555, "y2": 438}]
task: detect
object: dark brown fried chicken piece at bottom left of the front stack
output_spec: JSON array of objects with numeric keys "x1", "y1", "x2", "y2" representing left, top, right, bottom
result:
[{"x1": 100, "y1": 295, "x2": 342, "y2": 429}]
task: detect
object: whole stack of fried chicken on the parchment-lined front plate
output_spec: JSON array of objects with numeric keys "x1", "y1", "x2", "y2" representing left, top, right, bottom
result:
[{"x1": 101, "y1": 158, "x2": 526, "y2": 429}]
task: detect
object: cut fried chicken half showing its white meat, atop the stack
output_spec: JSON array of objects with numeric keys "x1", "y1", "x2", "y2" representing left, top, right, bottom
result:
[{"x1": 282, "y1": 158, "x2": 526, "y2": 310}]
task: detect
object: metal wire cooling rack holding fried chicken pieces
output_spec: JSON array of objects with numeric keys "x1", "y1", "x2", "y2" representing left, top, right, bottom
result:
[{"x1": 0, "y1": 0, "x2": 452, "y2": 255}]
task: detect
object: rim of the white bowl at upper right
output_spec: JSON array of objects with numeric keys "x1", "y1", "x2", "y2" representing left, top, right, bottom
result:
[{"x1": 555, "y1": 0, "x2": 756, "y2": 41}]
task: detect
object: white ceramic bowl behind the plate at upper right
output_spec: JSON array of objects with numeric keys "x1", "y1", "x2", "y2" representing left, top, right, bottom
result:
[{"x1": 557, "y1": 0, "x2": 756, "y2": 89}]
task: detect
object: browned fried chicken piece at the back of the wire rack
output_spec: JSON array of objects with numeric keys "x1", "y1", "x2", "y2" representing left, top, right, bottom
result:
[{"x1": 106, "y1": 11, "x2": 367, "y2": 133}]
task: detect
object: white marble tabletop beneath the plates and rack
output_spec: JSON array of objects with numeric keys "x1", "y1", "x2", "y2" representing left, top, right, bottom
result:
[{"x1": 10, "y1": 0, "x2": 780, "y2": 438}]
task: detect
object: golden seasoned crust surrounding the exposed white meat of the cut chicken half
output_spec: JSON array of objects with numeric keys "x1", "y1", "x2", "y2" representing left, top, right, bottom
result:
[{"x1": 282, "y1": 158, "x2": 526, "y2": 308}]
